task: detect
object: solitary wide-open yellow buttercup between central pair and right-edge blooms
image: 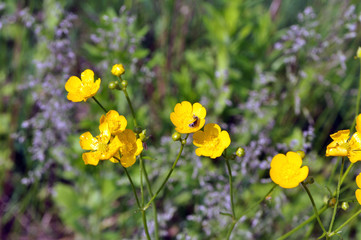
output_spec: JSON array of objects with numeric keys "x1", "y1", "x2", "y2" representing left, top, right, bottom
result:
[{"x1": 270, "y1": 152, "x2": 309, "y2": 188}]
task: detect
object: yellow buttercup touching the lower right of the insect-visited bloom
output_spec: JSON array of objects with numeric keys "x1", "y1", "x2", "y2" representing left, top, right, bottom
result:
[{"x1": 193, "y1": 123, "x2": 231, "y2": 158}]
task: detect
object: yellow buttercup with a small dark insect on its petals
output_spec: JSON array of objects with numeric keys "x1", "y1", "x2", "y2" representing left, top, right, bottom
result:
[{"x1": 170, "y1": 101, "x2": 206, "y2": 133}]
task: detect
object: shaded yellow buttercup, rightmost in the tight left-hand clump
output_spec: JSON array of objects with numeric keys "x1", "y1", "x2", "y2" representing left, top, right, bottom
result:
[{"x1": 110, "y1": 129, "x2": 143, "y2": 168}]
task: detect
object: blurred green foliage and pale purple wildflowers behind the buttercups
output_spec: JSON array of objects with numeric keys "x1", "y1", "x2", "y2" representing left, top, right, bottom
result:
[{"x1": 0, "y1": 0, "x2": 361, "y2": 239}]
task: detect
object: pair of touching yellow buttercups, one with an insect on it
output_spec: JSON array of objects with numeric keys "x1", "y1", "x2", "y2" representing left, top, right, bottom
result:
[{"x1": 170, "y1": 101, "x2": 231, "y2": 158}]
